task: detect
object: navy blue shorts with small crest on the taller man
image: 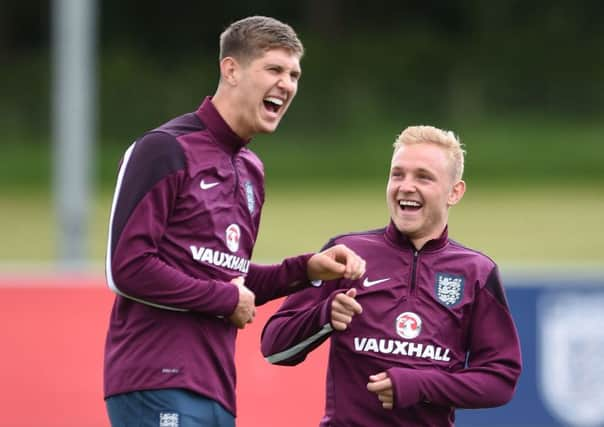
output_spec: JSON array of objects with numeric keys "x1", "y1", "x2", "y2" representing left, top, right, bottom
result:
[{"x1": 105, "y1": 389, "x2": 235, "y2": 427}]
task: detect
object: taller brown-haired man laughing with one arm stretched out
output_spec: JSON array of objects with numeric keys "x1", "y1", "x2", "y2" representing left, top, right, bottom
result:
[{"x1": 105, "y1": 16, "x2": 364, "y2": 427}]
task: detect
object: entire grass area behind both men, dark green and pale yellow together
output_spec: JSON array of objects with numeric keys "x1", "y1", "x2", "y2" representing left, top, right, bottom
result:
[{"x1": 0, "y1": 115, "x2": 604, "y2": 265}]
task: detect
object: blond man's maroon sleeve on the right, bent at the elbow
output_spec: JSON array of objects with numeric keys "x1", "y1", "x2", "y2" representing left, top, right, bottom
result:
[{"x1": 388, "y1": 268, "x2": 522, "y2": 408}]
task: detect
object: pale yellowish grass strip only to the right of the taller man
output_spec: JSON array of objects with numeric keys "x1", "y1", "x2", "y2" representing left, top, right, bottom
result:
[{"x1": 251, "y1": 185, "x2": 604, "y2": 265}]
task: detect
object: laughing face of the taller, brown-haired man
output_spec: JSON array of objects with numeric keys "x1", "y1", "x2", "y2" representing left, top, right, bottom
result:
[{"x1": 213, "y1": 48, "x2": 302, "y2": 139}]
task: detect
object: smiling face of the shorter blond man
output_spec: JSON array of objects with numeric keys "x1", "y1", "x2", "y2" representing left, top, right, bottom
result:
[{"x1": 386, "y1": 143, "x2": 465, "y2": 249}]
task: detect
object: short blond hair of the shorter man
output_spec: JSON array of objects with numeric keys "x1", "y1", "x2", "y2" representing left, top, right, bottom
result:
[{"x1": 393, "y1": 126, "x2": 466, "y2": 181}]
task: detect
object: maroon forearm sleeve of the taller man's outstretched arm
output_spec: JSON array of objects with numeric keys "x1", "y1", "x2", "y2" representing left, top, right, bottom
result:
[{"x1": 245, "y1": 253, "x2": 313, "y2": 305}]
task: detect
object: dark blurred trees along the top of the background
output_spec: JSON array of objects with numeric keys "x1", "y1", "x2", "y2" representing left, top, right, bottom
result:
[{"x1": 0, "y1": 0, "x2": 604, "y2": 144}]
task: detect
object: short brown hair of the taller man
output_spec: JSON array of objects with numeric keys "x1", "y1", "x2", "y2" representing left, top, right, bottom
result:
[{"x1": 219, "y1": 16, "x2": 304, "y2": 62}]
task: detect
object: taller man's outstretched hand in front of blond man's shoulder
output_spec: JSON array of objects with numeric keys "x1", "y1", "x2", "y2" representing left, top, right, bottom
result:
[{"x1": 306, "y1": 245, "x2": 365, "y2": 280}]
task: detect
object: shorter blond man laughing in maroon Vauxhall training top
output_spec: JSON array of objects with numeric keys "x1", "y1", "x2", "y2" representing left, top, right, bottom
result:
[{"x1": 262, "y1": 126, "x2": 521, "y2": 427}]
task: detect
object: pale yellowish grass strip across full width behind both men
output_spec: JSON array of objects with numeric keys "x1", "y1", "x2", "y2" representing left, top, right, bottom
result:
[{"x1": 0, "y1": 183, "x2": 604, "y2": 267}]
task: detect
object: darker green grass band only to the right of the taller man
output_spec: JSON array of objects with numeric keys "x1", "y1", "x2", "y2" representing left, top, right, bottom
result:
[{"x1": 252, "y1": 115, "x2": 604, "y2": 187}]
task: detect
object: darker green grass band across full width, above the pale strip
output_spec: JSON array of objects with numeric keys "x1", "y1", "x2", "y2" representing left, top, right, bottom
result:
[{"x1": 0, "y1": 110, "x2": 604, "y2": 192}]
